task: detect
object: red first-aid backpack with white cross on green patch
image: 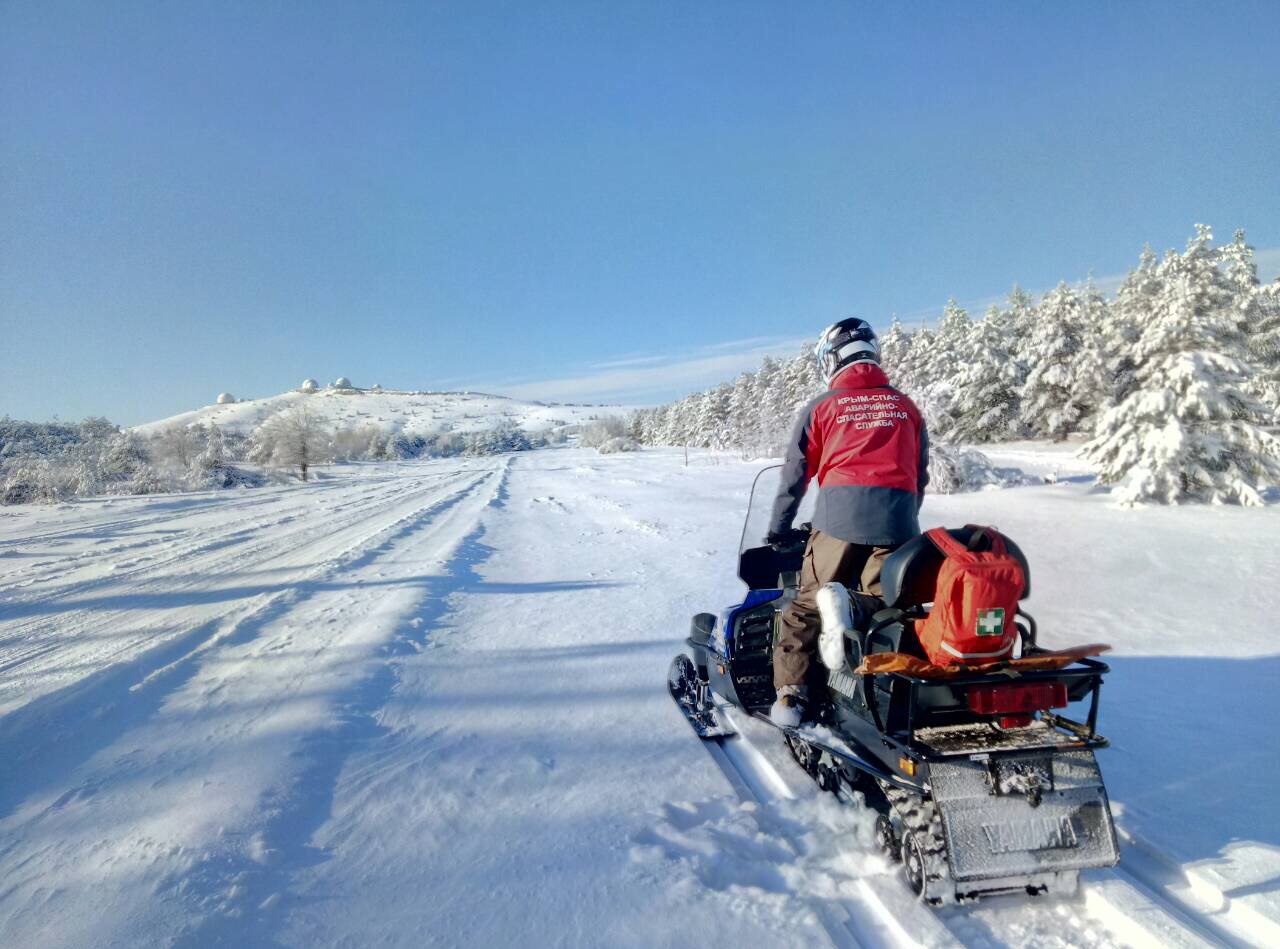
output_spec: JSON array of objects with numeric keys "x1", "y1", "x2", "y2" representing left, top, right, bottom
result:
[{"x1": 916, "y1": 524, "x2": 1025, "y2": 666}]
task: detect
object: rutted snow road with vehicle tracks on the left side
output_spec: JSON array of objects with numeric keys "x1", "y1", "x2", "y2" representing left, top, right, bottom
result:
[{"x1": 0, "y1": 461, "x2": 506, "y2": 945}]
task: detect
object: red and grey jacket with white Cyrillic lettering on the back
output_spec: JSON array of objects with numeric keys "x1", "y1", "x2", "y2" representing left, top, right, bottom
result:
[{"x1": 771, "y1": 362, "x2": 929, "y2": 546}]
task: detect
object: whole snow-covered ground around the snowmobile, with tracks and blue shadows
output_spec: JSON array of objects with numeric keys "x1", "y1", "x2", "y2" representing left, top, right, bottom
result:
[{"x1": 0, "y1": 444, "x2": 1280, "y2": 946}]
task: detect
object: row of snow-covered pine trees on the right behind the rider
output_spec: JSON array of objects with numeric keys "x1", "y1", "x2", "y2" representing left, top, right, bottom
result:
[{"x1": 630, "y1": 225, "x2": 1280, "y2": 503}]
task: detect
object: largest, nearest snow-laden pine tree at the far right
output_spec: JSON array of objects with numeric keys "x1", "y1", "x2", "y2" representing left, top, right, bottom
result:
[{"x1": 1084, "y1": 224, "x2": 1280, "y2": 505}]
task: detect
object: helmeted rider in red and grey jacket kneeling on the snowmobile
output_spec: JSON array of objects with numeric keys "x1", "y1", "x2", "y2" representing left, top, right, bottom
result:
[{"x1": 768, "y1": 318, "x2": 929, "y2": 726}]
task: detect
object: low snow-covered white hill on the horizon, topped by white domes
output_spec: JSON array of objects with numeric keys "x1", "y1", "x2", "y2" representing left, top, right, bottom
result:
[{"x1": 134, "y1": 387, "x2": 626, "y2": 437}]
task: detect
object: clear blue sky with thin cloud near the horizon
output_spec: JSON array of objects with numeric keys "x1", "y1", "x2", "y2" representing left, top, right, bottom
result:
[{"x1": 0, "y1": 0, "x2": 1280, "y2": 424}]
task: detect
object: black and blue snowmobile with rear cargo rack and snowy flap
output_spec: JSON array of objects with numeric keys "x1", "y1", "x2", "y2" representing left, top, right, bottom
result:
[{"x1": 668, "y1": 467, "x2": 1119, "y2": 905}]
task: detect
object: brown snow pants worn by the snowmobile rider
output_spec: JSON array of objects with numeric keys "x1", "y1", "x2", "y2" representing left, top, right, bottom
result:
[{"x1": 773, "y1": 530, "x2": 897, "y2": 688}]
